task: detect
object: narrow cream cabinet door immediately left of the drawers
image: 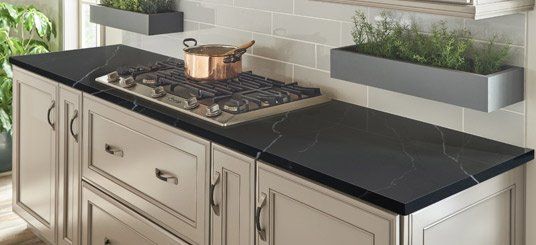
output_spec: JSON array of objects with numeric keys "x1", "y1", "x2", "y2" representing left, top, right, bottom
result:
[{"x1": 58, "y1": 86, "x2": 82, "y2": 245}]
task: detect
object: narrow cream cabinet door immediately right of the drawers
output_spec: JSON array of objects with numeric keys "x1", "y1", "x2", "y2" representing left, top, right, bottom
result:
[{"x1": 210, "y1": 144, "x2": 255, "y2": 245}]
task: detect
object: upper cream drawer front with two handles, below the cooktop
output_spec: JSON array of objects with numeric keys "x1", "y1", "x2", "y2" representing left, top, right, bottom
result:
[{"x1": 88, "y1": 113, "x2": 198, "y2": 221}]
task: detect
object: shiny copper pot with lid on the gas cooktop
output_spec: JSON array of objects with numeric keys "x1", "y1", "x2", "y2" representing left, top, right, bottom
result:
[{"x1": 183, "y1": 38, "x2": 255, "y2": 81}]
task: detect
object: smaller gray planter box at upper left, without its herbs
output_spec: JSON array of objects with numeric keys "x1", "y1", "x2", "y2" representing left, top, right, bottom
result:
[{"x1": 90, "y1": 5, "x2": 184, "y2": 35}]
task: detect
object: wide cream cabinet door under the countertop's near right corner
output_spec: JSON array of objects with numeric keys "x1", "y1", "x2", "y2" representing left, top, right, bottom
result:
[{"x1": 255, "y1": 163, "x2": 398, "y2": 245}]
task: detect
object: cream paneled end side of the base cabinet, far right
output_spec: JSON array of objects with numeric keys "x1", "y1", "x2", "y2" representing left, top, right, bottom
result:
[{"x1": 402, "y1": 167, "x2": 525, "y2": 245}]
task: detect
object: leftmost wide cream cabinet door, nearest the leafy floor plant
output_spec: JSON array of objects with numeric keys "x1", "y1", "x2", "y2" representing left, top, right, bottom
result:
[{"x1": 13, "y1": 69, "x2": 58, "y2": 243}]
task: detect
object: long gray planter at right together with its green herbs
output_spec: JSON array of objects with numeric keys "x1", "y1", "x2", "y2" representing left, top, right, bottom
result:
[{"x1": 331, "y1": 12, "x2": 524, "y2": 112}]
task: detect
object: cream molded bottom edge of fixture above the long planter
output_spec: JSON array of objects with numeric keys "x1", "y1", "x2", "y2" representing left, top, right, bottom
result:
[{"x1": 314, "y1": 0, "x2": 535, "y2": 19}]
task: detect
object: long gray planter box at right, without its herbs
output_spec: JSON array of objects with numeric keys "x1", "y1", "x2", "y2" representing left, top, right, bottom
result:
[{"x1": 331, "y1": 46, "x2": 525, "y2": 112}]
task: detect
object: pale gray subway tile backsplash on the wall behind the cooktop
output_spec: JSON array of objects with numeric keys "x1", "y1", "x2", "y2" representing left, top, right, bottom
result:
[{"x1": 123, "y1": 0, "x2": 526, "y2": 145}]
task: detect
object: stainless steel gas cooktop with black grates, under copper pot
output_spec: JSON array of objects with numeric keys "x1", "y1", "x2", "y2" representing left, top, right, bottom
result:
[{"x1": 96, "y1": 60, "x2": 329, "y2": 126}]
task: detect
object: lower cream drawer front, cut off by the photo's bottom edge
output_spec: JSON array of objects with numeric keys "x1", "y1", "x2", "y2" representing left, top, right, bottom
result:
[{"x1": 82, "y1": 184, "x2": 187, "y2": 245}]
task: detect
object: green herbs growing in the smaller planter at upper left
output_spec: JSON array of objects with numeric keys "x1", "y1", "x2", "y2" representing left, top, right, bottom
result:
[{"x1": 101, "y1": 0, "x2": 175, "y2": 14}]
